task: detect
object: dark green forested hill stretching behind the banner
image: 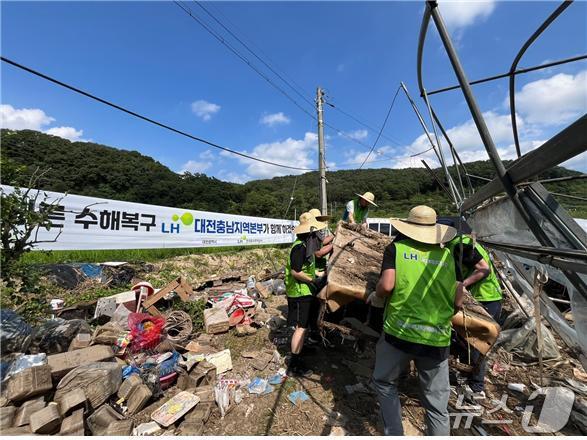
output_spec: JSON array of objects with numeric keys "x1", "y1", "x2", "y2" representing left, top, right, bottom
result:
[{"x1": 1, "y1": 130, "x2": 587, "y2": 218}]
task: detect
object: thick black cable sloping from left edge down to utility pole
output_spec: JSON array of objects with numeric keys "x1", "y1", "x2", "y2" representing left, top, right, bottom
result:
[{"x1": 0, "y1": 56, "x2": 316, "y2": 171}]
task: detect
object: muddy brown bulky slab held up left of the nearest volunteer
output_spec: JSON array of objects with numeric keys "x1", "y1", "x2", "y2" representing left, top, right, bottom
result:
[{"x1": 320, "y1": 221, "x2": 392, "y2": 312}]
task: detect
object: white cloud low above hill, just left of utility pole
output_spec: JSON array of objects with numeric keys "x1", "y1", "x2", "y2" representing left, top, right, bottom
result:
[{"x1": 226, "y1": 132, "x2": 318, "y2": 179}]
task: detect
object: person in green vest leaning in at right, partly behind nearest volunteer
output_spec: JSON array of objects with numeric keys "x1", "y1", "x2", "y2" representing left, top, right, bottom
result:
[{"x1": 442, "y1": 219, "x2": 502, "y2": 400}]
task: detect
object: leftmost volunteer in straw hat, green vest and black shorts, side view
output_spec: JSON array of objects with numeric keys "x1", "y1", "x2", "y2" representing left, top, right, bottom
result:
[{"x1": 285, "y1": 212, "x2": 328, "y2": 376}]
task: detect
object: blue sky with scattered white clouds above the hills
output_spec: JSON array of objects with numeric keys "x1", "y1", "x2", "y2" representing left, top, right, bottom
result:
[{"x1": 0, "y1": 1, "x2": 587, "y2": 182}]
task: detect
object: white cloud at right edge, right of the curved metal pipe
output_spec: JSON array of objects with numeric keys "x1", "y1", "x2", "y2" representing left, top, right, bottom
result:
[{"x1": 506, "y1": 70, "x2": 587, "y2": 126}]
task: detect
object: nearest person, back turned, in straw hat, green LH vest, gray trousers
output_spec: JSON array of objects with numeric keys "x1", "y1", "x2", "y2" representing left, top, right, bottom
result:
[{"x1": 367, "y1": 206, "x2": 464, "y2": 435}]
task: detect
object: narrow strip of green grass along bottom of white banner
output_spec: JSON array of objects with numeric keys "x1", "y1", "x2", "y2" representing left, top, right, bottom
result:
[{"x1": 21, "y1": 244, "x2": 290, "y2": 264}]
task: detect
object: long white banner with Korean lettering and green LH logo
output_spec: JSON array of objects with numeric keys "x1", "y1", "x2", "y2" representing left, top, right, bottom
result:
[{"x1": 2, "y1": 185, "x2": 298, "y2": 250}]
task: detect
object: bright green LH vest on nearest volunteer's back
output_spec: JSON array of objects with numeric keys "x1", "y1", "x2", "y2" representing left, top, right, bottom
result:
[{"x1": 383, "y1": 240, "x2": 457, "y2": 347}]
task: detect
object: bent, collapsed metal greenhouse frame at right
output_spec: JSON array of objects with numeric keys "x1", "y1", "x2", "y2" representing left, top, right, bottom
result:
[{"x1": 417, "y1": 0, "x2": 587, "y2": 298}]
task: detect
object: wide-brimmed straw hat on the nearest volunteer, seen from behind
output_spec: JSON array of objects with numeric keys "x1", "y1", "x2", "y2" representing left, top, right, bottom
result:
[{"x1": 389, "y1": 205, "x2": 457, "y2": 244}]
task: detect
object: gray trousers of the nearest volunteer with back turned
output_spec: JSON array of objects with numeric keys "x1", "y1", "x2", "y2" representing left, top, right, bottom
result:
[{"x1": 373, "y1": 336, "x2": 450, "y2": 435}]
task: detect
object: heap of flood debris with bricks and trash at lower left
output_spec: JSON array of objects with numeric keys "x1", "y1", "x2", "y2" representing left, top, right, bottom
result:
[{"x1": 0, "y1": 271, "x2": 285, "y2": 436}]
